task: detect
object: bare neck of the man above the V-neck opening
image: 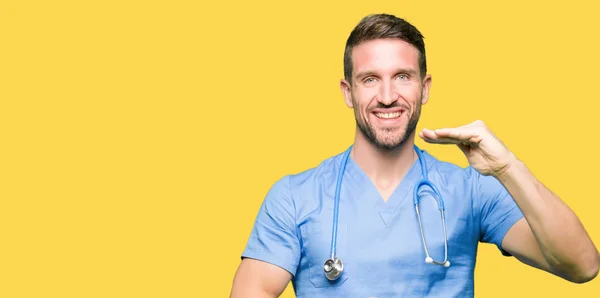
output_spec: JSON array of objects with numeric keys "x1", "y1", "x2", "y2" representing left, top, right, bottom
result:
[{"x1": 350, "y1": 131, "x2": 418, "y2": 186}]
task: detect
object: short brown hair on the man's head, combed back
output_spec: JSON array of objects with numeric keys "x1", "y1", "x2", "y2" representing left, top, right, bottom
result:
[{"x1": 344, "y1": 14, "x2": 427, "y2": 82}]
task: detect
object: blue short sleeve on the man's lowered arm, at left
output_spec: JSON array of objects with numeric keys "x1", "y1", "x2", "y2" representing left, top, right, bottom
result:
[{"x1": 242, "y1": 176, "x2": 300, "y2": 275}]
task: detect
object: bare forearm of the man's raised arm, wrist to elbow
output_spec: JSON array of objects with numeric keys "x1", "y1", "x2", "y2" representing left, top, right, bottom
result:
[{"x1": 496, "y1": 161, "x2": 600, "y2": 281}]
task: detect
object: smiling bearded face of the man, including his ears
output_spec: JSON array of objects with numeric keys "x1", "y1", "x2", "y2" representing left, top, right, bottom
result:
[{"x1": 341, "y1": 39, "x2": 431, "y2": 150}]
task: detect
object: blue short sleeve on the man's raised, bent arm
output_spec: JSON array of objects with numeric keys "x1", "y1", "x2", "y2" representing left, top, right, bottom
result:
[{"x1": 473, "y1": 170, "x2": 523, "y2": 256}]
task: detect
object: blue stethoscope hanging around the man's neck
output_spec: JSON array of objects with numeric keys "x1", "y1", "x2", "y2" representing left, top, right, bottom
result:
[{"x1": 323, "y1": 145, "x2": 450, "y2": 280}]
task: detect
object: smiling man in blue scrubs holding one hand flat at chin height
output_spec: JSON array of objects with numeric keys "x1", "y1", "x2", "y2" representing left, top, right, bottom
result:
[{"x1": 231, "y1": 14, "x2": 600, "y2": 297}]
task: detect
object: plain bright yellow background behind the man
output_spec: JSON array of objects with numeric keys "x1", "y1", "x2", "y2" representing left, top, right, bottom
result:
[{"x1": 0, "y1": 0, "x2": 600, "y2": 298}]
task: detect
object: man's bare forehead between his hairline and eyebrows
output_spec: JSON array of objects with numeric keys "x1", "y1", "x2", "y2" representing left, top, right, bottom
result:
[{"x1": 352, "y1": 39, "x2": 419, "y2": 74}]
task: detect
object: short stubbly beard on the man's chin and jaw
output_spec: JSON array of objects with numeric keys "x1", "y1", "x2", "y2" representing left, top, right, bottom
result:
[{"x1": 355, "y1": 101, "x2": 421, "y2": 151}]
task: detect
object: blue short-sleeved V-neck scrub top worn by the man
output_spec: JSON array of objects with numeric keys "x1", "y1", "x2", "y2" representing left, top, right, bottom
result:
[{"x1": 242, "y1": 147, "x2": 523, "y2": 298}]
